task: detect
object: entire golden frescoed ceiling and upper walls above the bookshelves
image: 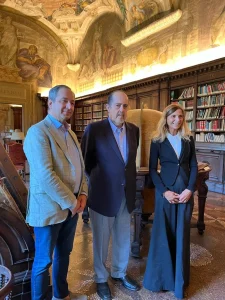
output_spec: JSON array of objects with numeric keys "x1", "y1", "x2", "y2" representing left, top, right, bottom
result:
[{"x1": 0, "y1": 0, "x2": 225, "y2": 94}]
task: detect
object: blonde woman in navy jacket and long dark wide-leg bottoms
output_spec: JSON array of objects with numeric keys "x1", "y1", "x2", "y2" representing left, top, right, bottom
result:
[{"x1": 143, "y1": 104, "x2": 198, "y2": 298}]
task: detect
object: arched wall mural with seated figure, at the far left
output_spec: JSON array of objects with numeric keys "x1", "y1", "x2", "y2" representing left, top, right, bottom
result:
[{"x1": 0, "y1": 9, "x2": 67, "y2": 88}]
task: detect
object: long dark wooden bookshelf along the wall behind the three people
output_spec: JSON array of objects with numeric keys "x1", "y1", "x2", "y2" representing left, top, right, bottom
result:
[{"x1": 72, "y1": 58, "x2": 225, "y2": 193}]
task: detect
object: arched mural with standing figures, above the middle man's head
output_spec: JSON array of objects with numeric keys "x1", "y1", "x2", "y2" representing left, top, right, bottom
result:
[{"x1": 77, "y1": 14, "x2": 124, "y2": 81}]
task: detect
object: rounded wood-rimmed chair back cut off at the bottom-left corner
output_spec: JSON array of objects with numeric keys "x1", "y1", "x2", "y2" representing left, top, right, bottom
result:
[{"x1": 0, "y1": 265, "x2": 13, "y2": 300}]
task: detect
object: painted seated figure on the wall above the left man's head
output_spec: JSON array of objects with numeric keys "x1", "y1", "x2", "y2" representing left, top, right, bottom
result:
[{"x1": 16, "y1": 45, "x2": 52, "y2": 87}]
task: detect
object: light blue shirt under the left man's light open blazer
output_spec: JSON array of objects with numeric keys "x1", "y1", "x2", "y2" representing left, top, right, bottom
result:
[{"x1": 49, "y1": 115, "x2": 82, "y2": 194}]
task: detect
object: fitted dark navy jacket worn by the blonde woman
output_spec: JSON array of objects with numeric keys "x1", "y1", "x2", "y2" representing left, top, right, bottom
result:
[{"x1": 149, "y1": 136, "x2": 198, "y2": 194}]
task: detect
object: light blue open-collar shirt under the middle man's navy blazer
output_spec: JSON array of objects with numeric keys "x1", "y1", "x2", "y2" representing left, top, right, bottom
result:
[{"x1": 108, "y1": 118, "x2": 128, "y2": 163}]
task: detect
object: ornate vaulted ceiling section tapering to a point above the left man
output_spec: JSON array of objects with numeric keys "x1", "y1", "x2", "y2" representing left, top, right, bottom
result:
[{"x1": 0, "y1": 0, "x2": 172, "y2": 69}]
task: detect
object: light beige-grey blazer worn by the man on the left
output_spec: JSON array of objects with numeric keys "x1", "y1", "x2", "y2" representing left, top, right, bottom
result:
[{"x1": 24, "y1": 116, "x2": 88, "y2": 227}]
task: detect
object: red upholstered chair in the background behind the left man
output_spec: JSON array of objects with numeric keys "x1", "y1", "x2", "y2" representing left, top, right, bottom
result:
[{"x1": 6, "y1": 143, "x2": 26, "y2": 179}]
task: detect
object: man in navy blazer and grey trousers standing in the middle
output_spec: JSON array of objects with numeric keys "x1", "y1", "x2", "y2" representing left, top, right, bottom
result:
[{"x1": 81, "y1": 91, "x2": 139, "y2": 299}]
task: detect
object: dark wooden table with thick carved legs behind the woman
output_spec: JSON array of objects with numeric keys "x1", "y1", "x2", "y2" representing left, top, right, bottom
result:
[{"x1": 131, "y1": 167, "x2": 211, "y2": 257}]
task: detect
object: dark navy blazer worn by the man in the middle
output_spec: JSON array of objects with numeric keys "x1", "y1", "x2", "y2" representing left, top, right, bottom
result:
[{"x1": 81, "y1": 119, "x2": 139, "y2": 217}]
